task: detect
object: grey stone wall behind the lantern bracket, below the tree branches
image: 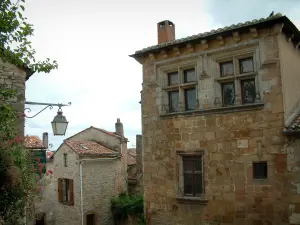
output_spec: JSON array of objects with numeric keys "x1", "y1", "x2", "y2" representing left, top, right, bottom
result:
[{"x1": 0, "y1": 58, "x2": 26, "y2": 136}]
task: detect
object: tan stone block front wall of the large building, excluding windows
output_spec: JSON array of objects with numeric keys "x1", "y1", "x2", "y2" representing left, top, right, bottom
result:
[{"x1": 142, "y1": 23, "x2": 289, "y2": 225}]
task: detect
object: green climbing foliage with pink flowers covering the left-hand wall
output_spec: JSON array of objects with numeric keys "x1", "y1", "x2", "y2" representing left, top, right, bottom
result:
[{"x1": 0, "y1": 85, "x2": 39, "y2": 225}]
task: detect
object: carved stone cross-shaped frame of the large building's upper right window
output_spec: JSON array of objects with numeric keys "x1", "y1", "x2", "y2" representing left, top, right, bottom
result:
[{"x1": 214, "y1": 45, "x2": 261, "y2": 107}]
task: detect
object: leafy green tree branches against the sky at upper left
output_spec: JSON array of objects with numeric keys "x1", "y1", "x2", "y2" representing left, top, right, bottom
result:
[{"x1": 0, "y1": 0, "x2": 58, "y2": 73}]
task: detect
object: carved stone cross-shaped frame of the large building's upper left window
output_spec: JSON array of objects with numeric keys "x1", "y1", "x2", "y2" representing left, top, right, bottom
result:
[{"x1": 156, "y1": 58, "x2": 199, "y2": 115}]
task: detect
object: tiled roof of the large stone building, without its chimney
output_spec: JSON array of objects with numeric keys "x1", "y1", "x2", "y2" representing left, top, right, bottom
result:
[{"x1": 131, "y1": 13, "x2": 299, "y2": 57}]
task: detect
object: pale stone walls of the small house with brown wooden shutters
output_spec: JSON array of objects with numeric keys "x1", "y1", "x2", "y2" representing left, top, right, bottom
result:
[{"x1": 38, "y1": 145, "x2": 122, "y2": 225}]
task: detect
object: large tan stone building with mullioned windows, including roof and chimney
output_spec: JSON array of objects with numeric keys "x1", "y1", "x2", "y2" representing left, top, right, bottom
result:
[{"x1": 131, "y1": 14, "x2": 300, "y2": 225}]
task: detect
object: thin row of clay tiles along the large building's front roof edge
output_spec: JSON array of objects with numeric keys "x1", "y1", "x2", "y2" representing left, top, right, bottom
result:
[{"x1": 131, "y1": 13, "x2": 285, "y2": 56}]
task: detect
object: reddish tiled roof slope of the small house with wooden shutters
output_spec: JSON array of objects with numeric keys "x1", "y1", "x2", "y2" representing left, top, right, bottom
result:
[{"x1": 65, "y1": 140, "x2": 119, "y2": 156}]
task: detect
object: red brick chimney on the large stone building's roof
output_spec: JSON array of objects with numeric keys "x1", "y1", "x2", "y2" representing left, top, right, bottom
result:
[{"x1": 157, "y1": 20, "x2": 175, "y2": 44}]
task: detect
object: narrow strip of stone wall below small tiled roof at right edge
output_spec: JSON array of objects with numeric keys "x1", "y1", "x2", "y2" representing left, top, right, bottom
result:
[{"x1": 285, "y1": 138, "x2": 300, "y2": 224}]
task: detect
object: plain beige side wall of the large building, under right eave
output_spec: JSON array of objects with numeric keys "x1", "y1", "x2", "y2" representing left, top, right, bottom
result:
[{"x1": 278, "y1": 35, "x2": 300, "y2": 119}]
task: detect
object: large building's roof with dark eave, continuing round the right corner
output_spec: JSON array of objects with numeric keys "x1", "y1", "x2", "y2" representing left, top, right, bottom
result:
[{"x1": 130, "y1": 13, "x2": 300, "y2": 57}]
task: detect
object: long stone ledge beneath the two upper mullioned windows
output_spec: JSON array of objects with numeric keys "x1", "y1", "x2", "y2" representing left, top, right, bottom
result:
[{"x1": 161, "y1": 102, "x2": 265, "y2": 117}]
